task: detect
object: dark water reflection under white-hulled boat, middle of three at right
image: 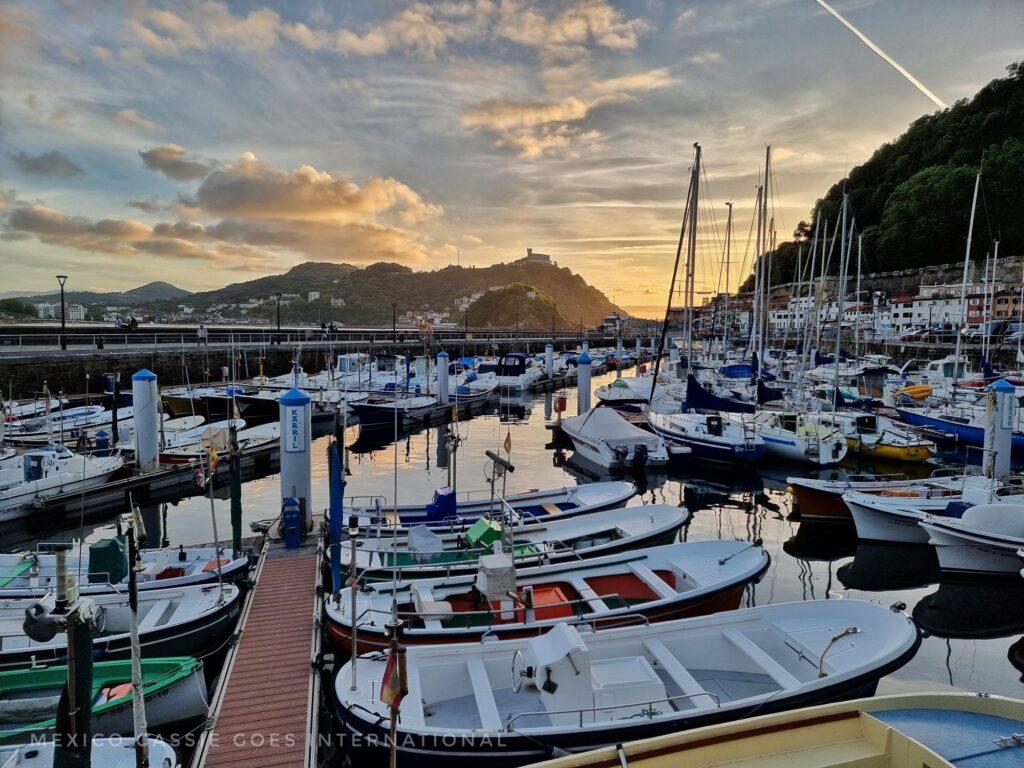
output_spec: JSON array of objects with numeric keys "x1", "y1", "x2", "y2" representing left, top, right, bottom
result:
[{"x1": 836, "y1": 542, "x2": 939, "y2": 592}]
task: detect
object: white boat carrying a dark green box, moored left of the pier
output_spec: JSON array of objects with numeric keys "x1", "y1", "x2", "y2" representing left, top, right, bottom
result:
[{"x1": 0, "y1": 539, "x2": 249, "y2": 598}]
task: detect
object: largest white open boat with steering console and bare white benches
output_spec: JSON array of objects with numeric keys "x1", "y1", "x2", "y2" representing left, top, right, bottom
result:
[{"x1": 334, "y1": 600, "x2": 920, "y2": 768}]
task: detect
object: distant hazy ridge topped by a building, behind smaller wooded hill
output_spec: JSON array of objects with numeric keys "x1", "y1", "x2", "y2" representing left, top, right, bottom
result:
[{"x1": 185, "y1": 259, "x2": 625, "y2": 328}]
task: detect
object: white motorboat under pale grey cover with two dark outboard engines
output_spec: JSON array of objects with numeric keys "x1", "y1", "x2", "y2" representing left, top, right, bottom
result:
[{"x1": 561, "y1": 408, "x2": 669, "y2": 469}]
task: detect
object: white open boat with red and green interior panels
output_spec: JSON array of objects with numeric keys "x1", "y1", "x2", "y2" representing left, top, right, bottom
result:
[{"x1": 325, "y1": 541, "x2": 769, "y2": 651}]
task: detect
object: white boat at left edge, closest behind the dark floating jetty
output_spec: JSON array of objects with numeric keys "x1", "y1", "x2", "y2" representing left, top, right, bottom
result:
[{"x1": 0, "y1": 445, "x2": 124, "y2": 522}]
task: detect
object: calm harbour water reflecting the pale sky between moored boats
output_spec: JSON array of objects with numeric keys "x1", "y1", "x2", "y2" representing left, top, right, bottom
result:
[{"x1": 4, "y1": 374, "x2": 1024, "y2": 697}]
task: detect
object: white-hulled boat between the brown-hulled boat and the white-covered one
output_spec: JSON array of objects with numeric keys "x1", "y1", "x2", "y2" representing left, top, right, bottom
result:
[{"x1": 843, "y1": 475, "x2": 1024, "y2": 544}]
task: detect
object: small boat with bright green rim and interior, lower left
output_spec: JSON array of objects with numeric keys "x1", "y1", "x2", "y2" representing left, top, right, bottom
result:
[{"x1": 0, "y1": 656, "x2": 210, "y2": 744}]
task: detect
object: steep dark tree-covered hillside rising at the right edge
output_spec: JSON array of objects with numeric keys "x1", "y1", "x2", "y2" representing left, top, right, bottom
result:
[{"x1": 744, "y1": 62, "x2": 1024, "y2": 289}]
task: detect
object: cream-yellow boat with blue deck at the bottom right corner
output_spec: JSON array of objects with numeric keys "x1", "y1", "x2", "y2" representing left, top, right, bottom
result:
[{"x1": 534, "y1": 692, "x2": 1024, "y2": 768}]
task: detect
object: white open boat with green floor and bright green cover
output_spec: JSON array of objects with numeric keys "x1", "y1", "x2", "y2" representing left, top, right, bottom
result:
[{"x1": 333, "y1": 504, "x2": 690, "y2": 581}]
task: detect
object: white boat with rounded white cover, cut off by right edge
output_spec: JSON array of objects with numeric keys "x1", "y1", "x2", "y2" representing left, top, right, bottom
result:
[{"x1": 920, "y1": 502, "x2": 1024, "y2": 577}]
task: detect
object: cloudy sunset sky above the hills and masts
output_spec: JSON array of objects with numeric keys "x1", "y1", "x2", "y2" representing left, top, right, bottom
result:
[{"x1": 0, "y1": 0, "x2": 1024, "y2": 311}]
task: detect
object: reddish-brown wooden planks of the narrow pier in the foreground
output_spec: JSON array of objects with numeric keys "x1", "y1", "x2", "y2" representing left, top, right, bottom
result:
[{"x1": 195, "y1": 544, "x2": 318, "y2": 768}]
